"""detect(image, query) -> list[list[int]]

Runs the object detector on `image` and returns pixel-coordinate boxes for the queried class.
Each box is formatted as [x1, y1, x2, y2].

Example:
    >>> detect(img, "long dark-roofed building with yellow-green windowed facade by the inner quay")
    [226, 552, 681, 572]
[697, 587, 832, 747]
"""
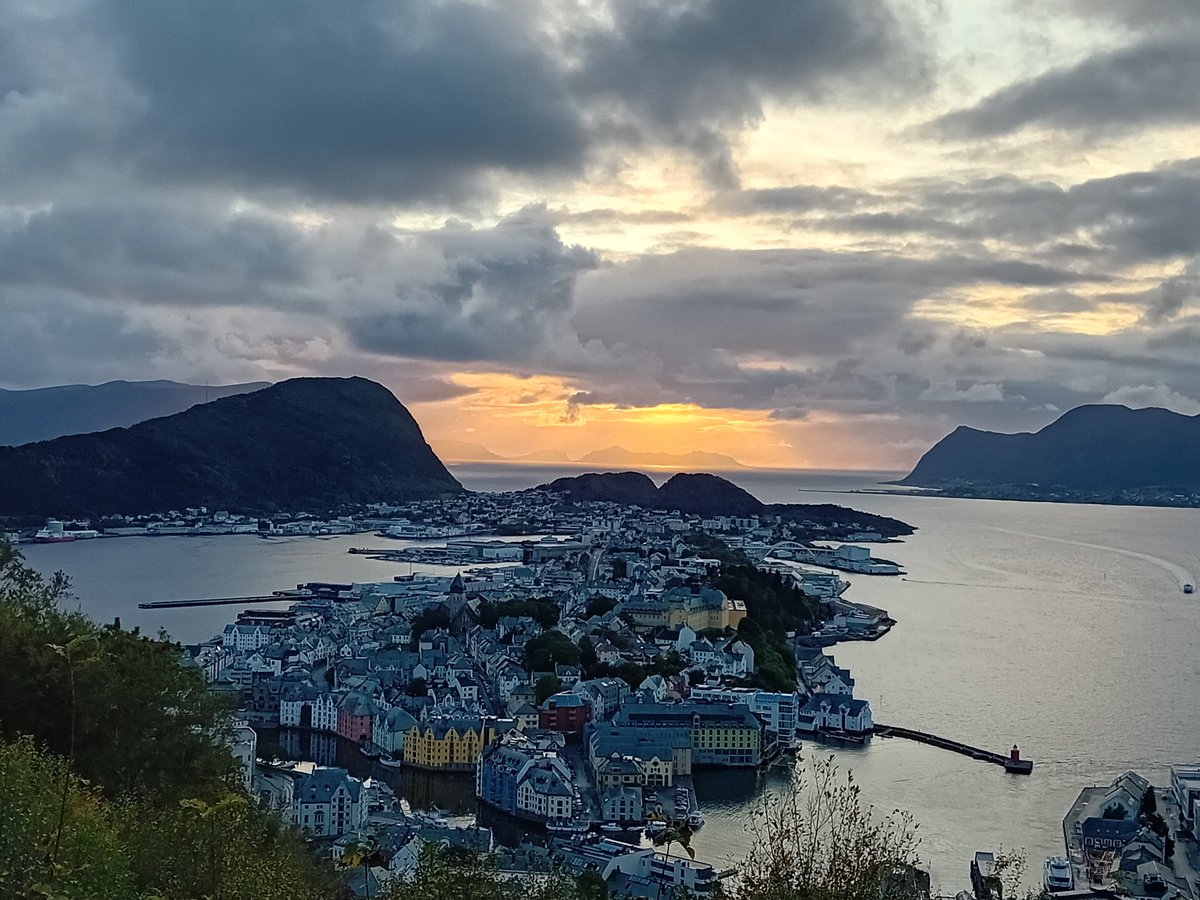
[614, 701, 762, 767]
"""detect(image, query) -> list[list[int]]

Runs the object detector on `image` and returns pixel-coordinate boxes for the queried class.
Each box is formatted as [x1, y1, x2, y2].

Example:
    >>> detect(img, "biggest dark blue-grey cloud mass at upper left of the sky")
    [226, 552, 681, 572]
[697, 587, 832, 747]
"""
[100, 0, 586, 200]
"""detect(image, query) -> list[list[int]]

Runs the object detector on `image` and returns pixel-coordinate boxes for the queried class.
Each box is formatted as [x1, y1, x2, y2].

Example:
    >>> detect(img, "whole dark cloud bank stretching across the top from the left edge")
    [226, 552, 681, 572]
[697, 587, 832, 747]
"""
[0, 0, 925, 204]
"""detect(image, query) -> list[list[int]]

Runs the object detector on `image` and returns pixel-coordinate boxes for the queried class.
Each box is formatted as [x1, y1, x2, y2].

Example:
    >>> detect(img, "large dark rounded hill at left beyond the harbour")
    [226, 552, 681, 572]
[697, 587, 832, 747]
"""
[0, 378, 462, 516]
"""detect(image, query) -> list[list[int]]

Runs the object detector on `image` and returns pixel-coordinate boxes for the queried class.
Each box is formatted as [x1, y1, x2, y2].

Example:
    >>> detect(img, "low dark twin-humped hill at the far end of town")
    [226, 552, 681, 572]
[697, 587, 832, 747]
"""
[532, 472, 913, 538]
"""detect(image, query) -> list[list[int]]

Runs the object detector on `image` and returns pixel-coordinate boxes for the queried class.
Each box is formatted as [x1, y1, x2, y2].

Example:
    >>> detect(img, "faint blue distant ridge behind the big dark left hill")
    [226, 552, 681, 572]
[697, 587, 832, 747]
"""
[0, 382, 270, 446]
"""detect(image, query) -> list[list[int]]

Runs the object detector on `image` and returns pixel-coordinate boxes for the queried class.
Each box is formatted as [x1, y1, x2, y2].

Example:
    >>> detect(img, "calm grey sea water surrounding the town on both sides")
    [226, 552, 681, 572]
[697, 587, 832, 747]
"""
[18, 464, 1200, 892]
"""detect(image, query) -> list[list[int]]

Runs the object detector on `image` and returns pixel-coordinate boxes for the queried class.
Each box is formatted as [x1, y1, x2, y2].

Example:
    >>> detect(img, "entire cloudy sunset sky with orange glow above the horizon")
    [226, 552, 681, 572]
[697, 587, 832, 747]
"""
[0, 0, 1200, 469]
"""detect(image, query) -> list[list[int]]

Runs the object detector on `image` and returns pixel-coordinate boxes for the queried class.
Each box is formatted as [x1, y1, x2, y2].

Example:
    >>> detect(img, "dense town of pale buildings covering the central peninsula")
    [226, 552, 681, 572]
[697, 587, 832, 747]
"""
[171, 492, 899, 895]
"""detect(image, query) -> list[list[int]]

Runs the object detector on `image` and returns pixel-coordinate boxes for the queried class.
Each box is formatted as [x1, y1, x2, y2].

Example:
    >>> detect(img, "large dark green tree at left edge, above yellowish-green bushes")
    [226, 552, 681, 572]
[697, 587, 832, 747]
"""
[0, 546, 234, 799]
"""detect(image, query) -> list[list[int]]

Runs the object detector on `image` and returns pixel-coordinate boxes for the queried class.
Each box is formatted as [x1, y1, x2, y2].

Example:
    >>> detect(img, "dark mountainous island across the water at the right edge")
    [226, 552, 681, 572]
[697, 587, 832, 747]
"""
[895, 404, 1200, 506]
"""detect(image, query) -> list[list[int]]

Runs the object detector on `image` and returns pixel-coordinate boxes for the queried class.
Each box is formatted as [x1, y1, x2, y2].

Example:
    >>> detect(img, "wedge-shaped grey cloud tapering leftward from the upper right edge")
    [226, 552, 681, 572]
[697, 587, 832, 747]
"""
[926, 32, 1200, 138]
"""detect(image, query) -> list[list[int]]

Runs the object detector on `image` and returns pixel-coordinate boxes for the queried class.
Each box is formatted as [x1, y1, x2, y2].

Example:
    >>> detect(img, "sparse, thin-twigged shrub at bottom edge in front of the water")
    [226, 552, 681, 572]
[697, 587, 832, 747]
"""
[731, 756, 918, 900]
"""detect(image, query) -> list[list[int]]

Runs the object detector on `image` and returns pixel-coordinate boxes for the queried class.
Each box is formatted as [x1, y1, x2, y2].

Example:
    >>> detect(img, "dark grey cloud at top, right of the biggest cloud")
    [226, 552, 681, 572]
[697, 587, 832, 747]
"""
[574, 0, 929, 187]
